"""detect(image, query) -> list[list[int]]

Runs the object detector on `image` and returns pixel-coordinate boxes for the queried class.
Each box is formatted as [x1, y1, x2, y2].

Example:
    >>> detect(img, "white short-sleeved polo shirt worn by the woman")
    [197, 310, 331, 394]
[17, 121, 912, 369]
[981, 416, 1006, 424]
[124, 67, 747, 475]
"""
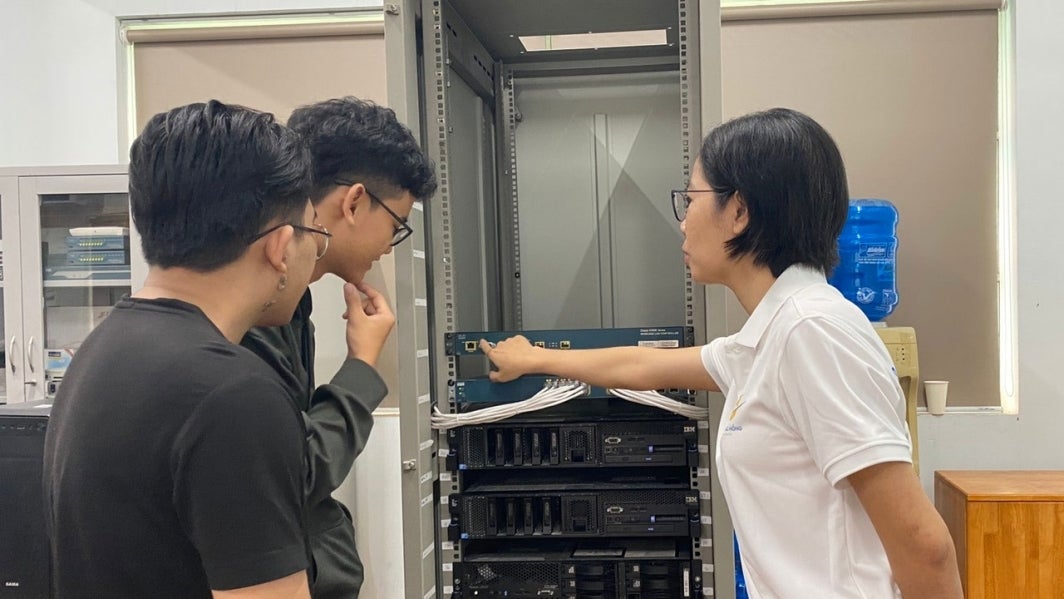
[702, 266, 912, 599]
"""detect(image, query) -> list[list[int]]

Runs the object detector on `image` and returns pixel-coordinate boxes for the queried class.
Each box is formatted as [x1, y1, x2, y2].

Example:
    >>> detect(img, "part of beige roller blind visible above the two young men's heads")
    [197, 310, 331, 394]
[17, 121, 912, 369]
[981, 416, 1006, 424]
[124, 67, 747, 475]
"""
[127, 23, 387, 131]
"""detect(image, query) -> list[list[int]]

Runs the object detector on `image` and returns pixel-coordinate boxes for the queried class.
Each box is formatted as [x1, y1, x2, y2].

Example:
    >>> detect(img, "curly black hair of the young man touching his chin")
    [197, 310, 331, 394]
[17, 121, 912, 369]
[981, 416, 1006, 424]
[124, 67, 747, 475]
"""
[288, 96, 436, 203]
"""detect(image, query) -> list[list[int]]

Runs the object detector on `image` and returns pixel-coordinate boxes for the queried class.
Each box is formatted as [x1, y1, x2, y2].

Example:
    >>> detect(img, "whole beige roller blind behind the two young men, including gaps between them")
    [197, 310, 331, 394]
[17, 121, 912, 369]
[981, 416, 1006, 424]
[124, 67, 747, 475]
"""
[124, 21, 401, 407]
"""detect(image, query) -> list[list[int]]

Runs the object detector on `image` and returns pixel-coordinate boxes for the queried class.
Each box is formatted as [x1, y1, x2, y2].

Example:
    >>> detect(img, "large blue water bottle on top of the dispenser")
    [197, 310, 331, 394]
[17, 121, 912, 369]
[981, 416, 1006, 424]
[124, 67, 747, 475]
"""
[828, 199, 898, 322]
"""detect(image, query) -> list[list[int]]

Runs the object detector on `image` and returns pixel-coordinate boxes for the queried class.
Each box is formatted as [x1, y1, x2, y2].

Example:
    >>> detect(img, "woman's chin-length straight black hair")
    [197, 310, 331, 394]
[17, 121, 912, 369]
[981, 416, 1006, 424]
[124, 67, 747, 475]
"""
[698, 109, 849, 277]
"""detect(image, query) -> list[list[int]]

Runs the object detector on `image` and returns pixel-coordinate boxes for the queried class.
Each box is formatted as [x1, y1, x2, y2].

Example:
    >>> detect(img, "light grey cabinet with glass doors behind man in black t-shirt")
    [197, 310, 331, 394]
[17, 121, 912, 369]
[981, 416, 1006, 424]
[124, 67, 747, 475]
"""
[0, 166, 143, 403]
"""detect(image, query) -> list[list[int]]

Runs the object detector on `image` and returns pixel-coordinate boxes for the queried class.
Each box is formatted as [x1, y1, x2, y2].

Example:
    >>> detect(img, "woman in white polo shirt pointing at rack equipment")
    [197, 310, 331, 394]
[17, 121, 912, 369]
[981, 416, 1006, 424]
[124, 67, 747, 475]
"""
[481, 109, 962, 599]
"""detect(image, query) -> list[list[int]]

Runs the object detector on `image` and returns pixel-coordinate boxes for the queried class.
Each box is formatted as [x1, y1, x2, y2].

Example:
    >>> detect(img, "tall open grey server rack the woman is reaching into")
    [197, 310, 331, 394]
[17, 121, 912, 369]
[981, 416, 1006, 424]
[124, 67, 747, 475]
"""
[384, 0, 730, 599]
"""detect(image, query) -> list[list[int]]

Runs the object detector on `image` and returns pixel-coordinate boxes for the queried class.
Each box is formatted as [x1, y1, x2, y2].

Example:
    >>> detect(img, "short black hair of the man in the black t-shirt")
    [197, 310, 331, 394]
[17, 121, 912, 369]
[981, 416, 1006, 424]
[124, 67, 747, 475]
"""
[130, 100, 311, 272]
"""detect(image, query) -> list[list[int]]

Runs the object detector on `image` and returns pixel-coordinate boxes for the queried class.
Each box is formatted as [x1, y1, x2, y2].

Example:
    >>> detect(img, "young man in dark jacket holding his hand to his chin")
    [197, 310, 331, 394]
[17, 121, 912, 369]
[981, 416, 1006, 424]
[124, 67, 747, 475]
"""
[243, 97, 436, 599]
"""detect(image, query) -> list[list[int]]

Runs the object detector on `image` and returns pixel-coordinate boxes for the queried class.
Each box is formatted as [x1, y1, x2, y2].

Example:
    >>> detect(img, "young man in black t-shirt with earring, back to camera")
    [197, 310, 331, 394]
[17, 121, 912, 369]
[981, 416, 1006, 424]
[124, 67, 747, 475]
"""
[45, 101, 336, 599]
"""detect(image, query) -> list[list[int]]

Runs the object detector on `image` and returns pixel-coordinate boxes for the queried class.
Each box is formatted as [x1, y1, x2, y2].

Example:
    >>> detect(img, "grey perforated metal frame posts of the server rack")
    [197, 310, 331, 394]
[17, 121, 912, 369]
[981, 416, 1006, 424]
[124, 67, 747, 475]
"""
[384, 0, 731, 599]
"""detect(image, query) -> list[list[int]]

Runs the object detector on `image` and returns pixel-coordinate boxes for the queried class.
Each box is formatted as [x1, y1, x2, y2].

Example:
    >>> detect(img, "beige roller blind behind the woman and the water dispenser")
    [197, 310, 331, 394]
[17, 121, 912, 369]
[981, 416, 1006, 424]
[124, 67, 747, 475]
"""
[721, 0, 1000, 405]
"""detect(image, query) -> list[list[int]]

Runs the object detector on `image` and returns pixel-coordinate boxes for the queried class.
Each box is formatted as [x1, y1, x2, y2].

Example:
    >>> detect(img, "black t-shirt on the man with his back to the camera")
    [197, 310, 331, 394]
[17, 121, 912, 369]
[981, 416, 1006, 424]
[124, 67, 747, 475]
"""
[45, 299, 307, 599]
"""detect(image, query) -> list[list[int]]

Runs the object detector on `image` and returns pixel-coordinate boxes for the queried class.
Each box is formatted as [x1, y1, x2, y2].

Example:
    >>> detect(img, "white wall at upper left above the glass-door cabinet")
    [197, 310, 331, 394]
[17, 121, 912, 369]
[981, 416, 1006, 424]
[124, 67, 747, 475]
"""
[0, 0, 381, 167]
